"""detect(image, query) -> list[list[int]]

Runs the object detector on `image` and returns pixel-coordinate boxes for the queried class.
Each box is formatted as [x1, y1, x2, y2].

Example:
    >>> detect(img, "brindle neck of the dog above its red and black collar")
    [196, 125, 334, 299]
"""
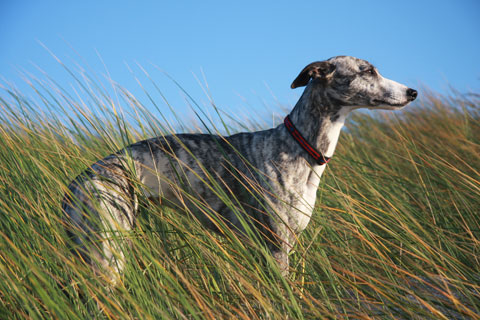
[284, 83, 350, 161]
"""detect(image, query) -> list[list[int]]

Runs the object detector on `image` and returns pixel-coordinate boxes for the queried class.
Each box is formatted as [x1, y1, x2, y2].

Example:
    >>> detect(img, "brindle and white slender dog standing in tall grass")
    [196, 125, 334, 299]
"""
[62, 56, 417, 282]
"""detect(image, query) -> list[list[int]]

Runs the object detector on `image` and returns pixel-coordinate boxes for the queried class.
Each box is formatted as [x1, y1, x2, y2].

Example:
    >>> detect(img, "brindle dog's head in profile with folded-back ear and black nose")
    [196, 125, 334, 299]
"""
[291, 56, 417, 109]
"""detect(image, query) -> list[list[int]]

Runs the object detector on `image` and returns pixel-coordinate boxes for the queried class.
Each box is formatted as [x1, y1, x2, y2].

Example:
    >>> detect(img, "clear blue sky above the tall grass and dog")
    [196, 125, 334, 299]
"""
[0, 0, 480, 120]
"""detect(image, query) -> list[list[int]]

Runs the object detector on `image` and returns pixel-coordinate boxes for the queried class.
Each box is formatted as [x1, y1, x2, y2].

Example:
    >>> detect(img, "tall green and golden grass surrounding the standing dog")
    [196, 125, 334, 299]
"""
[0, 69, 480, 319]
